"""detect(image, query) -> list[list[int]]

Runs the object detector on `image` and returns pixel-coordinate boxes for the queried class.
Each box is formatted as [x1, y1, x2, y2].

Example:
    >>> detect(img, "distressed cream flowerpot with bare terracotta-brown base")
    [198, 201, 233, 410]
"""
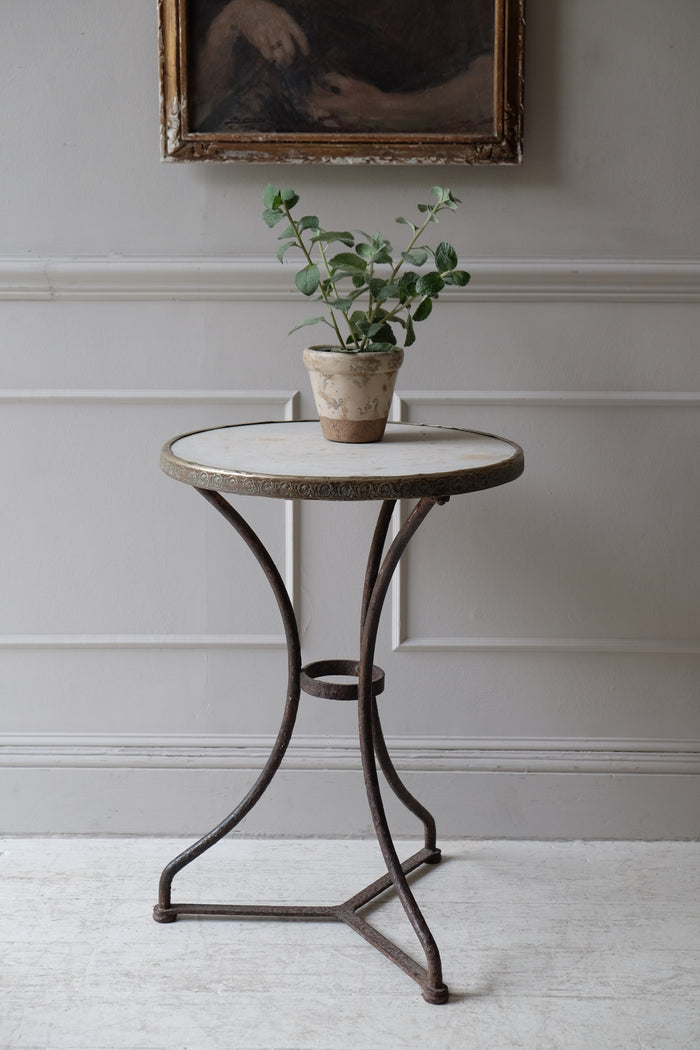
[303, 347, 403, 442]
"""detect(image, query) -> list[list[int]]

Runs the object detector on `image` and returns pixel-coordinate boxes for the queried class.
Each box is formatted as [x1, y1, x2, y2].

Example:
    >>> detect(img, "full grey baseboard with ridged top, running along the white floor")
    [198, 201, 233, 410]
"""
[0, 736, 700, 839]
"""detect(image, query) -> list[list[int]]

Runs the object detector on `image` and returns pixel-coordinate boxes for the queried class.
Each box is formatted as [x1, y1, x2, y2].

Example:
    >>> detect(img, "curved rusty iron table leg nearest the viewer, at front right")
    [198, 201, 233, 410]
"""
[358, 497, 448, 1003]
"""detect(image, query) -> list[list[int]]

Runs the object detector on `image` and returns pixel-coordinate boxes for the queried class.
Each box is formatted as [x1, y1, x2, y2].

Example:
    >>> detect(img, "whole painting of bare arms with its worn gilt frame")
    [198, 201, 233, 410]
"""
[158, 0, 525, 164]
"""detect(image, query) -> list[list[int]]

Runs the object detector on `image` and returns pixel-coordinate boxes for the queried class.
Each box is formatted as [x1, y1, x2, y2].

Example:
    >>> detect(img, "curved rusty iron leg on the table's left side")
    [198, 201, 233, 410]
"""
[153, 488, 301, 922]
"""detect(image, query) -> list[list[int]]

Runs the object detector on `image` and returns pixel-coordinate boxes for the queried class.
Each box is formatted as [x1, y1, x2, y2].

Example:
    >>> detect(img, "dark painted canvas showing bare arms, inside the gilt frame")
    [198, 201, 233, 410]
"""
[188, 0, 495, 134]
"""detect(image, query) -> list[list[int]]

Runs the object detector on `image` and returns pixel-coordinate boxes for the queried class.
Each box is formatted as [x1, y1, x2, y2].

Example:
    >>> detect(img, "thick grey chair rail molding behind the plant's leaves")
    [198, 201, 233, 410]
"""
[0, 255, 700, 302]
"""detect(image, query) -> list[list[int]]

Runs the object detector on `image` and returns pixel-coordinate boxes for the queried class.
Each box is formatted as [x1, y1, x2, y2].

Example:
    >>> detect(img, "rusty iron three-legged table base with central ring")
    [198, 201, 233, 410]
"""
[153, 488, 448, 1004]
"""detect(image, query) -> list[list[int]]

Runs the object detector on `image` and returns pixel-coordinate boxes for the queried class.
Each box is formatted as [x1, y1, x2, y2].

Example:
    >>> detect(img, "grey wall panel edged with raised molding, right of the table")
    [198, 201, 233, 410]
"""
[393, 391, 700, 654]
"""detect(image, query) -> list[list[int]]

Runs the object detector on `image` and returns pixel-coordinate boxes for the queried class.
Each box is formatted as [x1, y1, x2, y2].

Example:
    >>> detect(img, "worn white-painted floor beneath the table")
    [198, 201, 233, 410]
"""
[0, 838, 700, 1050]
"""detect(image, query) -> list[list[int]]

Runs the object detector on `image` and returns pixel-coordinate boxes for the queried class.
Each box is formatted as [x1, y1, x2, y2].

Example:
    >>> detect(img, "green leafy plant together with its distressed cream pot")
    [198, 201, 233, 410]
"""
[262, 185, 469, 442]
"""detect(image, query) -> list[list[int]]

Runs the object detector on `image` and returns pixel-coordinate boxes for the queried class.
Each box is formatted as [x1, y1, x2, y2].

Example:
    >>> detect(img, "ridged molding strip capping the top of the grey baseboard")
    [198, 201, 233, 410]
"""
[0, 733, 700, 776]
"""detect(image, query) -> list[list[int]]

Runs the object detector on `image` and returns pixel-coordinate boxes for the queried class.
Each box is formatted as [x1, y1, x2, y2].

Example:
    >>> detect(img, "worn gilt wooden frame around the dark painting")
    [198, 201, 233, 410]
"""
[158, 0, 525, 164]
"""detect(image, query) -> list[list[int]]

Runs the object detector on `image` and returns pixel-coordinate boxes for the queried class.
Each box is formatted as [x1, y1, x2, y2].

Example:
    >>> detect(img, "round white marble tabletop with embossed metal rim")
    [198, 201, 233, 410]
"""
[161, 422, 523, 500]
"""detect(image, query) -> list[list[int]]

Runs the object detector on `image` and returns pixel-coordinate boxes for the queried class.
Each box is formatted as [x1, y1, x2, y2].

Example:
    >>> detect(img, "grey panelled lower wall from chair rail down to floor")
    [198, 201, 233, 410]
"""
[0, 257, 700, 838]
